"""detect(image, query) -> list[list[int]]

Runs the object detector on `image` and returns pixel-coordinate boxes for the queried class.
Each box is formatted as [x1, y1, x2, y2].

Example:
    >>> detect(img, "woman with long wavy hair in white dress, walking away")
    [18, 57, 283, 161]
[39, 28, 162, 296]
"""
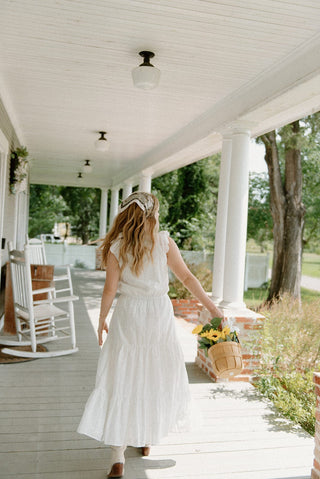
[78, 192, 223, 478]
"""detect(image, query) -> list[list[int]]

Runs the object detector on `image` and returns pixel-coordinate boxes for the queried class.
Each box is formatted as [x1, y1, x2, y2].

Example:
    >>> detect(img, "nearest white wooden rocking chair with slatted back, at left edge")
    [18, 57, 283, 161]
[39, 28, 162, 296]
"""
[0, 243, 79, 358]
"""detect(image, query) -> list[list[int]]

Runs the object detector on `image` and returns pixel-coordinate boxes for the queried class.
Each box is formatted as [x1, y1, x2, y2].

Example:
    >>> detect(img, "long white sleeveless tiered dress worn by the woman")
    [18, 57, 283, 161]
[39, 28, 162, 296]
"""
[77, 231, 190, 447]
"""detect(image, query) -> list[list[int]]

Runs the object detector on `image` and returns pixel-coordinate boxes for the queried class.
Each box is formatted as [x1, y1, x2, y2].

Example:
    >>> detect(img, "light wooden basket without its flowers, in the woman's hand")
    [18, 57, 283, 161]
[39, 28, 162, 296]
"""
[208, 341, 243, 378]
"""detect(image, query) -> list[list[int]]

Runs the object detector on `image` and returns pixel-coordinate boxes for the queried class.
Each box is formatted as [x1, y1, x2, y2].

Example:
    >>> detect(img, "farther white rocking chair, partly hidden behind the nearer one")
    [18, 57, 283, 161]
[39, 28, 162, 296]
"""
[26, 235, 73, 296]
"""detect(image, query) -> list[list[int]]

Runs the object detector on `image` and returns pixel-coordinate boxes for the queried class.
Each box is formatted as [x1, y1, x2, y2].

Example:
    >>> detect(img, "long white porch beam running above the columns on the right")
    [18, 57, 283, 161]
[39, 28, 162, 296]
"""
[114, 33, 320, 188]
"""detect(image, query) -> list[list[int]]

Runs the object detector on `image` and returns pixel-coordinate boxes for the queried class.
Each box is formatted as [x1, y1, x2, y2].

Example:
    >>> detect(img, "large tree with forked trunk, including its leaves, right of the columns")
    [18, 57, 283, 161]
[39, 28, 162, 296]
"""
[258, 113, 320, 301]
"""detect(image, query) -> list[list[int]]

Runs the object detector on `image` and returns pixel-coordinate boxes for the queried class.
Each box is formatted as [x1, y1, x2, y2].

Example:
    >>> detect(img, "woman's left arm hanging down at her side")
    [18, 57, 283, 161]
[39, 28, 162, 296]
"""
[98, 252, 120, 346]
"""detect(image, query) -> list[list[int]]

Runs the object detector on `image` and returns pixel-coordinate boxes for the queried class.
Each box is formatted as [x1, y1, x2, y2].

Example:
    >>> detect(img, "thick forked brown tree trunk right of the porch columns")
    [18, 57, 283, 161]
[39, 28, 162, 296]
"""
[261, 121, 305, 302]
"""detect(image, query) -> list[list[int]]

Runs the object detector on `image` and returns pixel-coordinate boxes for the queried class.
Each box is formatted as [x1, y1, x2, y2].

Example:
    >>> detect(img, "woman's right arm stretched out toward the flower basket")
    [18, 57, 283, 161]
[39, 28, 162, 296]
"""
[168, 238, 223, 318]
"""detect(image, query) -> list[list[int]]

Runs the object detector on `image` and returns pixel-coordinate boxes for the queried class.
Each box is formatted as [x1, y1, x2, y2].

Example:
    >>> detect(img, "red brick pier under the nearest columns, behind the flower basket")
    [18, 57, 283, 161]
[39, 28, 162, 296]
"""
[196, 308, 264, 384]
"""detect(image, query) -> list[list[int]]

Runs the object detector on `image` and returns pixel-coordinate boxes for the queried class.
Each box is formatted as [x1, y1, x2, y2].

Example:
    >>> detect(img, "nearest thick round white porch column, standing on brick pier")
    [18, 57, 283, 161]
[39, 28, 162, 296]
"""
[220, 127, 250, 309]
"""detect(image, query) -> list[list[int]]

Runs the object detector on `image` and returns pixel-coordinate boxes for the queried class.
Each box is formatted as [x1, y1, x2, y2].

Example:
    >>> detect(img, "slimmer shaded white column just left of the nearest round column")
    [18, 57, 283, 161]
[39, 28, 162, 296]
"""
[212, 134, 232, 303]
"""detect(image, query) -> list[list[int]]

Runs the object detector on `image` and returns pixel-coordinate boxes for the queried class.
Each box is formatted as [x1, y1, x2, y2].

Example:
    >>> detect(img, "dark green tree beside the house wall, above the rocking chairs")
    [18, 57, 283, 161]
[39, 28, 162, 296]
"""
[29, 185, 67, 238]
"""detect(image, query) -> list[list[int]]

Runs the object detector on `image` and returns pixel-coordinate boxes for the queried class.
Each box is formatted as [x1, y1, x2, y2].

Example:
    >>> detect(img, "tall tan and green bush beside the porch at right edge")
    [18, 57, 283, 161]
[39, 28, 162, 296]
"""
[255, 296, 320, 434]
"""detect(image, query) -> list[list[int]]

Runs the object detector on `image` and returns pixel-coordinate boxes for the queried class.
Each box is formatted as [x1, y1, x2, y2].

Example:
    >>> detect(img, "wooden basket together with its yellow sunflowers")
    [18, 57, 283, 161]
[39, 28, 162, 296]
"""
[192, 318, 243, 378]
